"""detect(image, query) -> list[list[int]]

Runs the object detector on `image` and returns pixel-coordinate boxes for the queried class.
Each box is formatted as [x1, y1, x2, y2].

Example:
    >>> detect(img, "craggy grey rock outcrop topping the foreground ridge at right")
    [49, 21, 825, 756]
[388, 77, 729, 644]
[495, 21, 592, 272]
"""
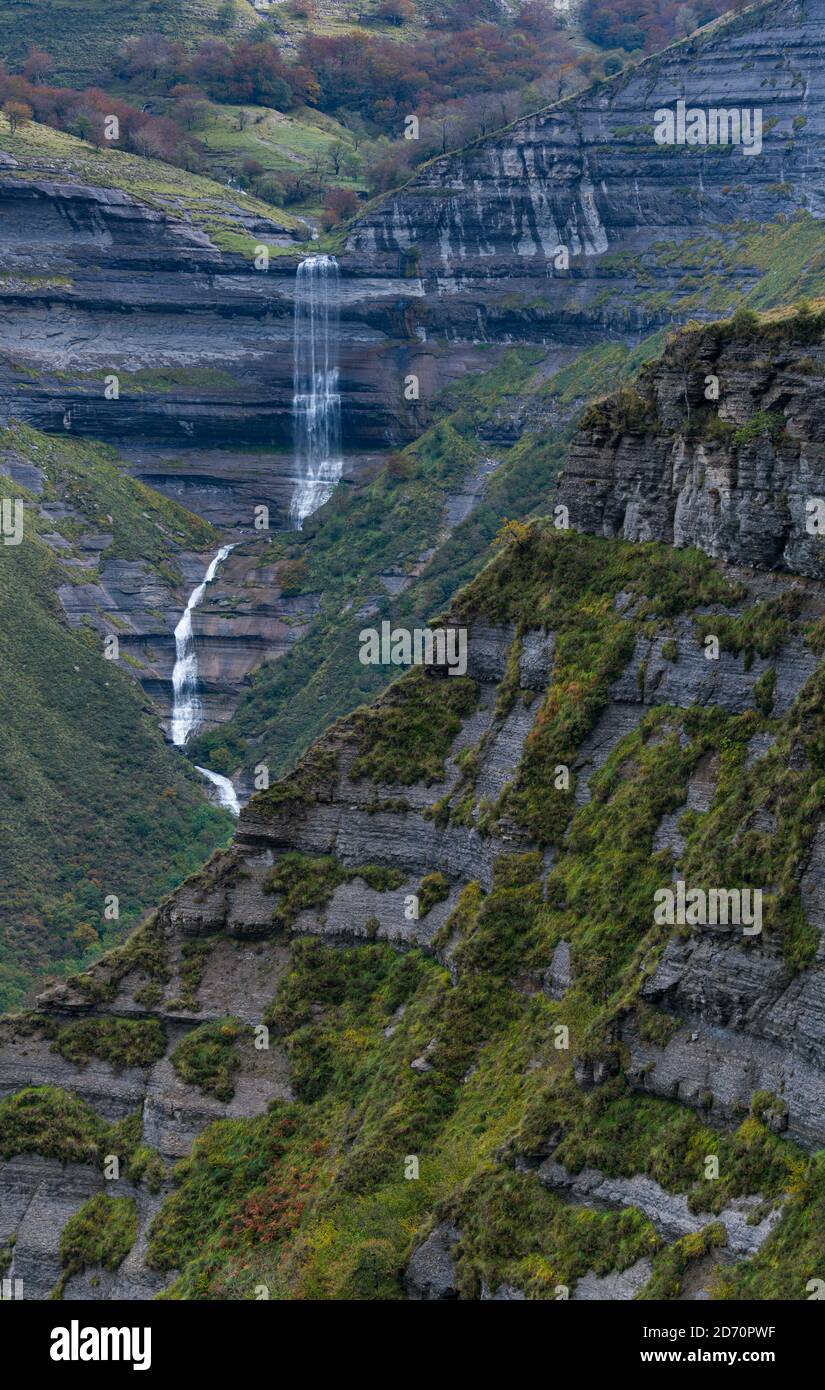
[558, 316, 825, 580]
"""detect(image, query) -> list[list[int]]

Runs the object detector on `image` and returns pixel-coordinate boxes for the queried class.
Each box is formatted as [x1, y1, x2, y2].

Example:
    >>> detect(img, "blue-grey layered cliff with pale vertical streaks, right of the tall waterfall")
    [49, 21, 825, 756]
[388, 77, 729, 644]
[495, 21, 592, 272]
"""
[349, 0, 825, 329]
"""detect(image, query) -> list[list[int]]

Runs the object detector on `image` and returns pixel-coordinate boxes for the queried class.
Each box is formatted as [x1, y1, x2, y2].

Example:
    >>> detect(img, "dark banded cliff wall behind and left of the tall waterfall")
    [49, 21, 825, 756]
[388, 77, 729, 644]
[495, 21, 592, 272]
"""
[0, 170, 408, 503]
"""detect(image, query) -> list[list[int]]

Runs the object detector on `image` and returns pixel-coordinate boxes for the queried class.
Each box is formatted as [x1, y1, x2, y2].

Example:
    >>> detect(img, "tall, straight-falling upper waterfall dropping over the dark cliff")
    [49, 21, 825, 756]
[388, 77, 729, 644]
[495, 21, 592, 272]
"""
[289, 256, 342, 531]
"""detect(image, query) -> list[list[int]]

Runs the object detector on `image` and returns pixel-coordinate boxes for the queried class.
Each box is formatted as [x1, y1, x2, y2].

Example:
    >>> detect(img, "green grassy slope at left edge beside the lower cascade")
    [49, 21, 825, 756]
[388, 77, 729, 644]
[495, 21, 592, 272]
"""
[0, 430, 231, 1009]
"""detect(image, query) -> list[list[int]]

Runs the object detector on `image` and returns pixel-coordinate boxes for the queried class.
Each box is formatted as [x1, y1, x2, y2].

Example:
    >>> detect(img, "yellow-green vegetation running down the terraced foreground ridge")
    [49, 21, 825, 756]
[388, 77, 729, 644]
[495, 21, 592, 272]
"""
[165, 523, 825, 1298]
